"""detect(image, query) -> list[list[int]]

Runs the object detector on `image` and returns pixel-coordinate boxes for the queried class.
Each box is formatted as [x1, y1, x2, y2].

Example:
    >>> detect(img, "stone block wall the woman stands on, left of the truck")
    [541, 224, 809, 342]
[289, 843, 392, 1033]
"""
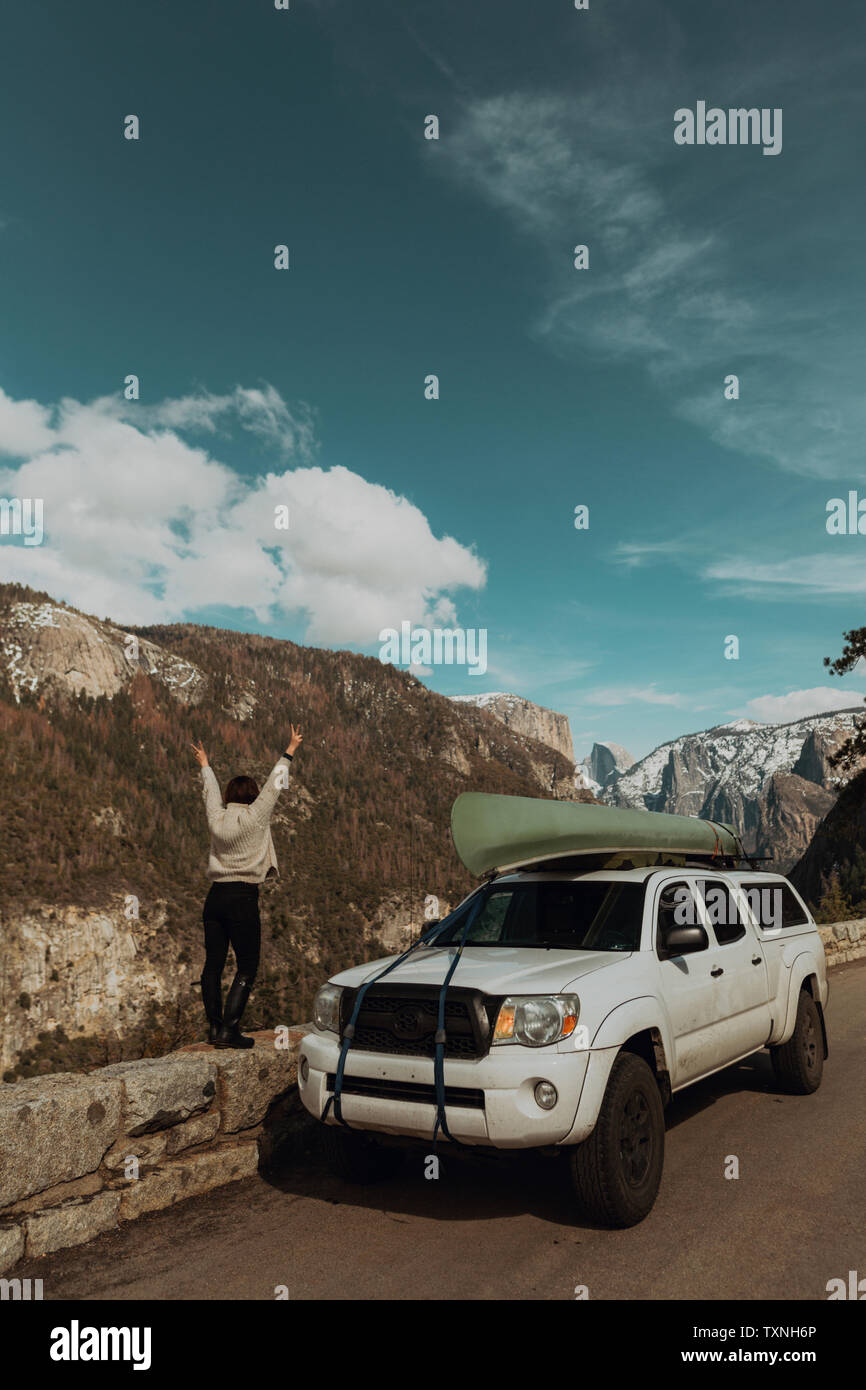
[0, 1024, 310, 1273]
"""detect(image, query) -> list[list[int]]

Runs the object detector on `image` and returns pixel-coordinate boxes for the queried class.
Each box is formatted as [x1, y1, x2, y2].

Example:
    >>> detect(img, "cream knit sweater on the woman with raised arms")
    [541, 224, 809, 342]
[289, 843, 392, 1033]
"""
[202, 756, 292, 883]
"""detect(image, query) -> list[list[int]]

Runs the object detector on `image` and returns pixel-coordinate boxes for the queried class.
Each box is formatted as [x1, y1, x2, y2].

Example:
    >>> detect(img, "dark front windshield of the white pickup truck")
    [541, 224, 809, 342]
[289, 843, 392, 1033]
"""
[428, 880, 644, 951]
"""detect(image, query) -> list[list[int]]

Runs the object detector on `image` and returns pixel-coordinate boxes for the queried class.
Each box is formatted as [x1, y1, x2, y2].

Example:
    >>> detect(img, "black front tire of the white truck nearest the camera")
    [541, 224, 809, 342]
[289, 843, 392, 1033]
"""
[569, 1052, 664, 1226]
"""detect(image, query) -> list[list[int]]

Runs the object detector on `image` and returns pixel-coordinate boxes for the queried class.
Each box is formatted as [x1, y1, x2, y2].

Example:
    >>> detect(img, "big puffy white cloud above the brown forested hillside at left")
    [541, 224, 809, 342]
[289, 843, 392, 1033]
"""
[0, 388, 487, 648]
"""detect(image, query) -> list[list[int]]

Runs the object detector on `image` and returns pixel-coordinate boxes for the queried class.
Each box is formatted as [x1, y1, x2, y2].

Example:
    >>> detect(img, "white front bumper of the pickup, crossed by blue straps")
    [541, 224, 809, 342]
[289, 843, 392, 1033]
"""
[297, 1031, 589, 1148]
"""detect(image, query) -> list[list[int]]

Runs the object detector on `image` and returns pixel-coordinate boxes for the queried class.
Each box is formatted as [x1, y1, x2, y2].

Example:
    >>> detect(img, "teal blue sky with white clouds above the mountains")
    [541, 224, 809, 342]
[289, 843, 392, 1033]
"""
[0, 0, 866, 756]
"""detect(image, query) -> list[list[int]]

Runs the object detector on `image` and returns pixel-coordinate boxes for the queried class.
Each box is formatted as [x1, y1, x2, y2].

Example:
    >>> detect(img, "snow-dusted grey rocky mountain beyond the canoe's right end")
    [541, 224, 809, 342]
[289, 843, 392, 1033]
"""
[601, 710, 862, 873]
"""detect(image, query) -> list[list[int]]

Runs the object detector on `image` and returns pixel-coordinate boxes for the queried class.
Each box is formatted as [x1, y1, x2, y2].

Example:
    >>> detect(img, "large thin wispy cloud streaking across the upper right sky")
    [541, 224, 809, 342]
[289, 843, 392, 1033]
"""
[435, 63, 866, 477]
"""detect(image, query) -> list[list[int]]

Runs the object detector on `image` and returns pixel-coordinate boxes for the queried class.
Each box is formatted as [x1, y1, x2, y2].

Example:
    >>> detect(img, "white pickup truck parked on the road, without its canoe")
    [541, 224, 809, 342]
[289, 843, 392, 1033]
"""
[299, 865, 828, 1226]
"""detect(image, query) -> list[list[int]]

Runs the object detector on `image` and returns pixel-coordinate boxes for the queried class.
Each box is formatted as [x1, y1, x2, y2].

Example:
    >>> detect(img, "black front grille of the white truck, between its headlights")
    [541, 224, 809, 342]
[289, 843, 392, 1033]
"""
[341, 983, 502, 1059]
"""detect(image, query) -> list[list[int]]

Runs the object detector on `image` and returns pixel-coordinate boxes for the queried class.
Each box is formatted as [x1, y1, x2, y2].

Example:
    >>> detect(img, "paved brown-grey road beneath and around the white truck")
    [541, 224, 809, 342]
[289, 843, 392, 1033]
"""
[15, 962, 866, 1300]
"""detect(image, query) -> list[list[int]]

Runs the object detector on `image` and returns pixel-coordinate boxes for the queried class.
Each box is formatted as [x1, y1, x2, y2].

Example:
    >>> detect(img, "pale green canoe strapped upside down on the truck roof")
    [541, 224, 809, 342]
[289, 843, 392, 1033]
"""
[450, 791, 742, 874]
